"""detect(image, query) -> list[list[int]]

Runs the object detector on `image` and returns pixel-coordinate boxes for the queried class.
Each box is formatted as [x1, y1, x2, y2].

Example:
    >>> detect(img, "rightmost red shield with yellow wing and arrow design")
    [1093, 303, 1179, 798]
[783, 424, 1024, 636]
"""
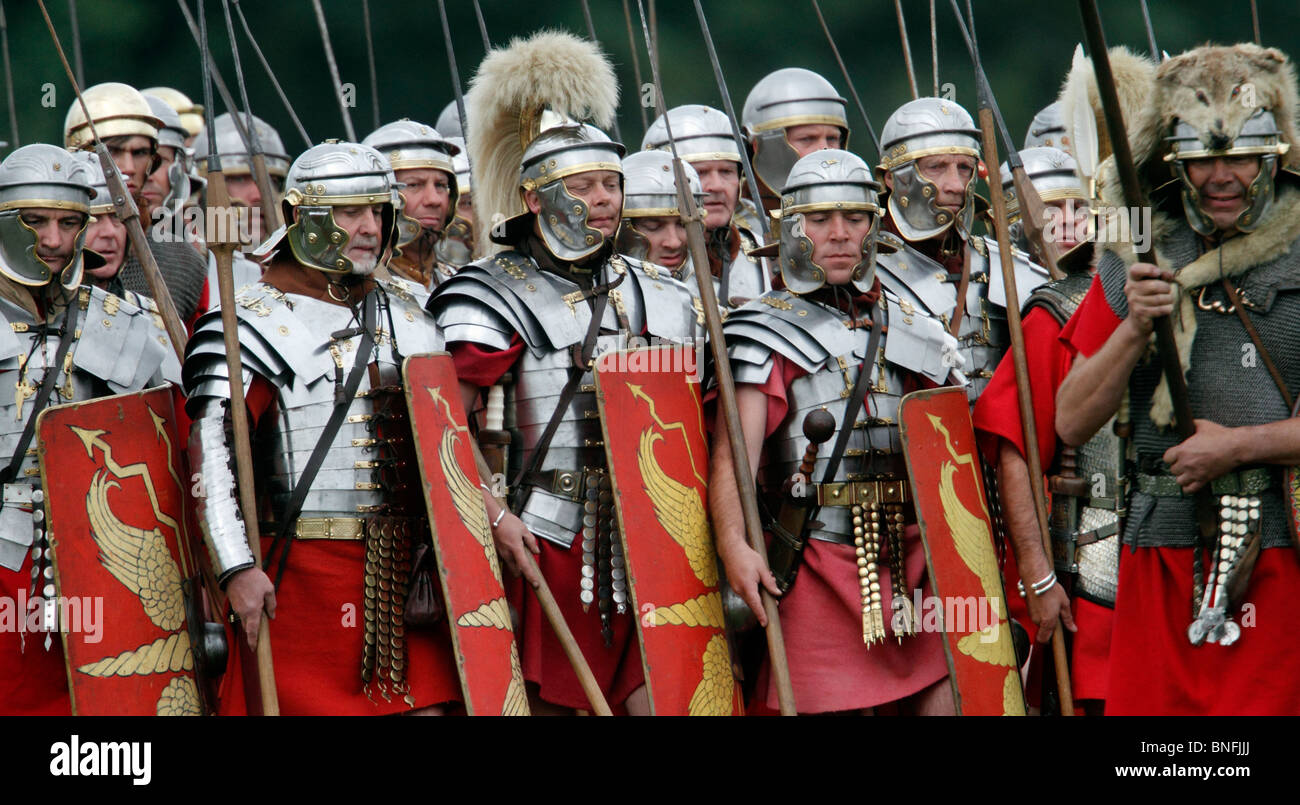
[898, 388, 1024, 715]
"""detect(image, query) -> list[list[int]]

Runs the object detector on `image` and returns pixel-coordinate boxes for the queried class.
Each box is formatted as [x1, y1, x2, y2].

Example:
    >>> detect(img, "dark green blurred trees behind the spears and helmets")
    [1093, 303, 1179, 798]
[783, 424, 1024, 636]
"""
[0, 0, 1300, 161]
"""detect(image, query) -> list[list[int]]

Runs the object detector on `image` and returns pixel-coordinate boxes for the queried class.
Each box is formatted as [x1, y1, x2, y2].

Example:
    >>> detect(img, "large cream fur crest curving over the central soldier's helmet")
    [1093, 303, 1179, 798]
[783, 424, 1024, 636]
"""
[465, 31, 619, 256]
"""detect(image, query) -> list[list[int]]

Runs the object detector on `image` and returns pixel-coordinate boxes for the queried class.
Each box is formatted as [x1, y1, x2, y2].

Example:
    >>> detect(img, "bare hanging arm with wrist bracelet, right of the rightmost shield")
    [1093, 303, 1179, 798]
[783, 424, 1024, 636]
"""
[997, 440, 1078, 642]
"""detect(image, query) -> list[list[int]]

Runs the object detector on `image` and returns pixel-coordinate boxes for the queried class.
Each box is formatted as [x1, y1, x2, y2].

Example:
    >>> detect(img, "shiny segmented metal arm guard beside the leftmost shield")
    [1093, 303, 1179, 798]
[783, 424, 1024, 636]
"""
[189, 398, 255, 585]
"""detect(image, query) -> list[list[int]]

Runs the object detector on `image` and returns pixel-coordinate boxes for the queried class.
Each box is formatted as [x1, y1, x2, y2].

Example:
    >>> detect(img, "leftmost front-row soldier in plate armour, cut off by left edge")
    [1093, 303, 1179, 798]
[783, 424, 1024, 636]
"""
[0, 144, 179, 715]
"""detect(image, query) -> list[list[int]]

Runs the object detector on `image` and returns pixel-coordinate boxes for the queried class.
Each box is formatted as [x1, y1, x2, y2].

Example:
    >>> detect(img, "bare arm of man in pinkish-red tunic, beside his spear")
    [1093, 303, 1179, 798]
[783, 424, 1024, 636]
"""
[709, 385, 780, 627]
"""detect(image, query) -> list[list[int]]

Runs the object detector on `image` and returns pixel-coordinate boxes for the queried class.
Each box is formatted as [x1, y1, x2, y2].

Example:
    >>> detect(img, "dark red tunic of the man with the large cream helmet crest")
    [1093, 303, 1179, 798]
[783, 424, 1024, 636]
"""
[447, 333, 645, 710]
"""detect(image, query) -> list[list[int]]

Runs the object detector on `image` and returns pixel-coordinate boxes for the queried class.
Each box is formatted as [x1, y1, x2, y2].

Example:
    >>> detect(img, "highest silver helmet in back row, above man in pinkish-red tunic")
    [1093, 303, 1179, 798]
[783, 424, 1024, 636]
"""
[743, 68, 849, 190]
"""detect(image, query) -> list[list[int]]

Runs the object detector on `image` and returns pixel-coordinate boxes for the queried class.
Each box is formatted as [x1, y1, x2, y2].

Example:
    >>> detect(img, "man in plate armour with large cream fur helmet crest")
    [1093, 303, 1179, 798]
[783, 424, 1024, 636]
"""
[429, 33, 698, 714]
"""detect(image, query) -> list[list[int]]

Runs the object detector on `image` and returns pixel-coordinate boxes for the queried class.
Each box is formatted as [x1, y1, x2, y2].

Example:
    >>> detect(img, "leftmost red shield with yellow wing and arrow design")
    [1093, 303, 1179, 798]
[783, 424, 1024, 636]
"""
[36, 386, 202, 715]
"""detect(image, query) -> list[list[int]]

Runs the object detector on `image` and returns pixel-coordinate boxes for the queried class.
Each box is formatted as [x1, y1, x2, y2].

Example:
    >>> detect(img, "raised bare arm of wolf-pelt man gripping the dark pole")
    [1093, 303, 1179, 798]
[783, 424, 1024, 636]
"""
[1056, 263, 1174, 447]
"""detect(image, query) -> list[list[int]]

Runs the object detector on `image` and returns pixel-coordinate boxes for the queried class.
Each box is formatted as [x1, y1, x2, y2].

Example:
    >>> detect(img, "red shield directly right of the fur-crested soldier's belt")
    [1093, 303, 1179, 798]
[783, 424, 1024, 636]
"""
[595, 346, 744, 715]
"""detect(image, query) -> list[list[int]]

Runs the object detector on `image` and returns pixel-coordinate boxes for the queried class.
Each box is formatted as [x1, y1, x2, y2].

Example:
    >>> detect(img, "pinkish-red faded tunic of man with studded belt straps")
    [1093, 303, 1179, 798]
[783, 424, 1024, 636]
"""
[758, 354, 948, 713]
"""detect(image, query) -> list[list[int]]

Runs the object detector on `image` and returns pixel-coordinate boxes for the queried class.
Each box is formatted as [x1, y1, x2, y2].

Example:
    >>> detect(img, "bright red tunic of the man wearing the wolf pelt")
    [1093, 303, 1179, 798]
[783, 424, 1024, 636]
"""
[1061, 280, 1300, 715]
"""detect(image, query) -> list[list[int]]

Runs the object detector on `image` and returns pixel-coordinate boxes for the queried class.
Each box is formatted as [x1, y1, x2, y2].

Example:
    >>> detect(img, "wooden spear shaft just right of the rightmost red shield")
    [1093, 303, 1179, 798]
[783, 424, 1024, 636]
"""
[967, 105, 1074, 715]
